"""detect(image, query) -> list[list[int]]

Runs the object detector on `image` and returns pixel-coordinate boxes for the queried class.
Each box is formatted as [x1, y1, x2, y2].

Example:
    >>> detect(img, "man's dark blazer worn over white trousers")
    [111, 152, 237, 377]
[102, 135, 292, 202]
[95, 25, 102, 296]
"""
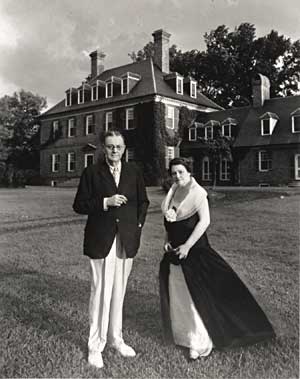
[73, 162, 149, 259]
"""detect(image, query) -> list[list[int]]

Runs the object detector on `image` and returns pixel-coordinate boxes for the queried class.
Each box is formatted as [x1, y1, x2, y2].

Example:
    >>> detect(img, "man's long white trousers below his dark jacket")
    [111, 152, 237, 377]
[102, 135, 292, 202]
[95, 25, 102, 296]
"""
[88, 234, 133, 351]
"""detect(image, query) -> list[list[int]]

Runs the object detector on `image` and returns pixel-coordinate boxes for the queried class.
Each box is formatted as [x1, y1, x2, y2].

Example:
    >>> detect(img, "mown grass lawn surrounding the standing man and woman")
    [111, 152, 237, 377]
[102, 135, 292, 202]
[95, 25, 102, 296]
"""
[0, 187, 300, 379]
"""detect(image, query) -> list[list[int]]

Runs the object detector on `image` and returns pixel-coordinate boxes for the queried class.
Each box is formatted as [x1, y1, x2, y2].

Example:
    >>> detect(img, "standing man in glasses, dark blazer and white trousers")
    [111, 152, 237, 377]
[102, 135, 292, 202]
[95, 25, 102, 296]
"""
[73, 131, 149, 368]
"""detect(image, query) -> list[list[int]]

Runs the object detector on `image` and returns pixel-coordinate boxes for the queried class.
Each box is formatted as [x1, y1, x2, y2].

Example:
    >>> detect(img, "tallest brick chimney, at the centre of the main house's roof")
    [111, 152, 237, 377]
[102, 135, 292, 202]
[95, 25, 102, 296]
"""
[152, 29, 171, 74]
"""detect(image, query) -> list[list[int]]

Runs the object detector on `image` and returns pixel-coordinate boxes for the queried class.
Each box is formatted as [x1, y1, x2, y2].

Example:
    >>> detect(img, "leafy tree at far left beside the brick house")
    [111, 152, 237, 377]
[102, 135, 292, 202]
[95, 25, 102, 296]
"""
[0, 90, 46, 183]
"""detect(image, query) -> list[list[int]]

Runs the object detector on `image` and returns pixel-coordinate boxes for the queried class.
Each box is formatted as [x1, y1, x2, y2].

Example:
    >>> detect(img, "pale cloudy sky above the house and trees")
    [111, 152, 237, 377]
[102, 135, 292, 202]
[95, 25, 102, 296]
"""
[0, 0, 300, 110]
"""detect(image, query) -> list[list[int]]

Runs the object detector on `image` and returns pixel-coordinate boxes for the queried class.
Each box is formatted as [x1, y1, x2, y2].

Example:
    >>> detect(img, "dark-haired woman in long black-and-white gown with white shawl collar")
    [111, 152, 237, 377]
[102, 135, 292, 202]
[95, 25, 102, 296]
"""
[160, 158, 275, 359]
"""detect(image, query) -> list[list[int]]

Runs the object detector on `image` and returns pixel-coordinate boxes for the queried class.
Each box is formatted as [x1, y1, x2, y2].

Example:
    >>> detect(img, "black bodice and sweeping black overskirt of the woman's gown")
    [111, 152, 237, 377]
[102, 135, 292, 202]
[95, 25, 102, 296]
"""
[159, 214, 275, 348]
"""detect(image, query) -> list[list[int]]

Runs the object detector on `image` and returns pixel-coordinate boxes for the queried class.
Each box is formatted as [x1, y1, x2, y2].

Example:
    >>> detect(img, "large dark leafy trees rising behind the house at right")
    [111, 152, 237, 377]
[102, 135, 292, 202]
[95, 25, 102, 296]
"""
[132, 23, 300, 108]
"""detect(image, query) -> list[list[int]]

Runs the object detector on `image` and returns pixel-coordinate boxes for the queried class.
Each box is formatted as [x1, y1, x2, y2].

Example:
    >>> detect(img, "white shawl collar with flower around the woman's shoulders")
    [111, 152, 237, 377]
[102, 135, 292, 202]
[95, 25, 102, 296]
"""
[161, 177, 207, 222]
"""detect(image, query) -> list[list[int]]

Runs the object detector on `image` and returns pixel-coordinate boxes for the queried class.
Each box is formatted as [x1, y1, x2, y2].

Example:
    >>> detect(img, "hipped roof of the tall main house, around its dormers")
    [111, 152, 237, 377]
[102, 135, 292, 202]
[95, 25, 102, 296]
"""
[41, 58, 223, 117]
